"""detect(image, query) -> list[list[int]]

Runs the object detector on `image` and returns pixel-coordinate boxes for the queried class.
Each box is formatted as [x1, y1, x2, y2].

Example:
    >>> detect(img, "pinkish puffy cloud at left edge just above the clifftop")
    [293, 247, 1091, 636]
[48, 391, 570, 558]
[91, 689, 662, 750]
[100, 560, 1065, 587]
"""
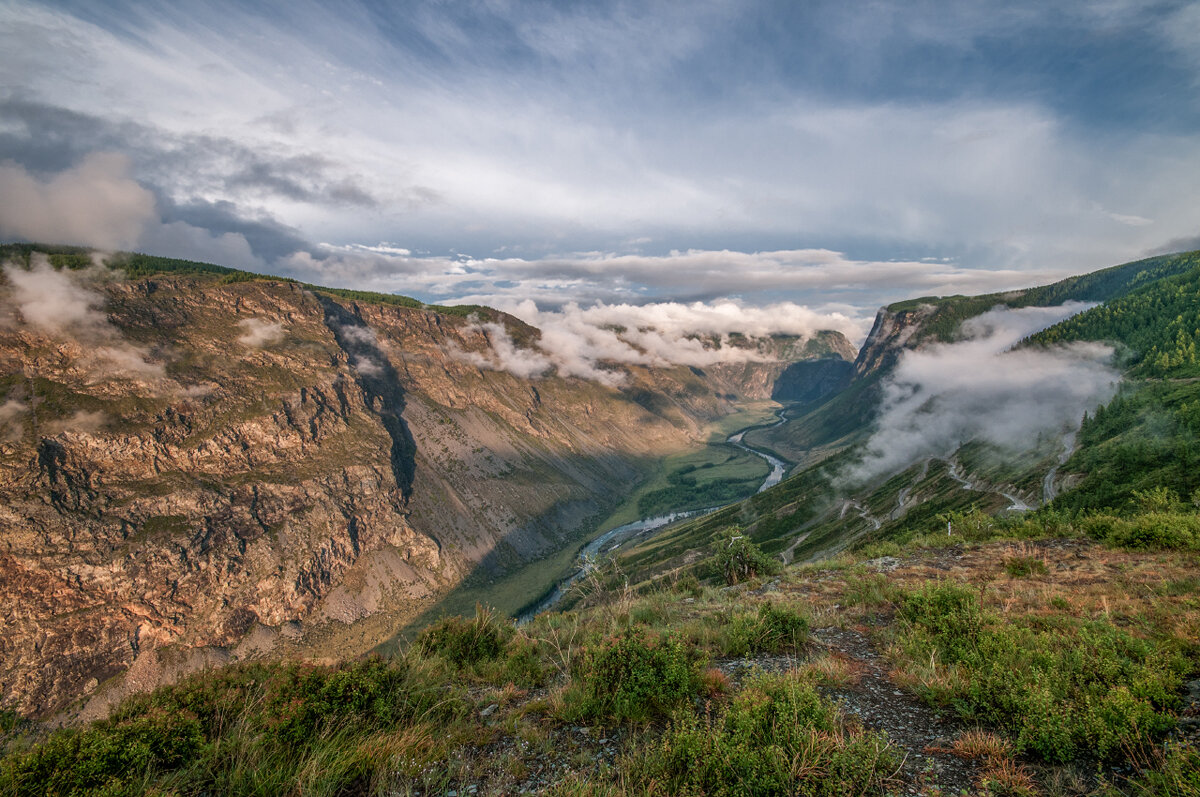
[0, 152, 155, 250]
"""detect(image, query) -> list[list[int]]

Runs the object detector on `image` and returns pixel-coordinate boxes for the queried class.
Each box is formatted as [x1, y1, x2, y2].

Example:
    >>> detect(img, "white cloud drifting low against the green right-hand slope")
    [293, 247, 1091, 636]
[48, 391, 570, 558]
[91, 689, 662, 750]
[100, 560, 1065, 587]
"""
[845, 302, 1121, 483]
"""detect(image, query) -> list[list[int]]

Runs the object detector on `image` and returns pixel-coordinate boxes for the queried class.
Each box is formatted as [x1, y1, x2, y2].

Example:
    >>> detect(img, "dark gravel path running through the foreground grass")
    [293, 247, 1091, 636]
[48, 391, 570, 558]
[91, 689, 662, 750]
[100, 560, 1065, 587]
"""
[812, 628, 976, 795]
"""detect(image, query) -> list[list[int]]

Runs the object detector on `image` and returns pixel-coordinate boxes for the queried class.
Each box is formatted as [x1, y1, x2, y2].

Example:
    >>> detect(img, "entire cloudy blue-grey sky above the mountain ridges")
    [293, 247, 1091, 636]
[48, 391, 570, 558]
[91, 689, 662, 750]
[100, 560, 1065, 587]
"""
[0, 0, 1200, 338]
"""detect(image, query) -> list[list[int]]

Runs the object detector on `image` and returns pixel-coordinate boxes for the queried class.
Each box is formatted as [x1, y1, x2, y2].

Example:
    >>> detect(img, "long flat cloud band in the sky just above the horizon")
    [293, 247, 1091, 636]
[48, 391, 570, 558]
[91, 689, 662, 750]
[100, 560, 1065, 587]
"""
[278, 246, 1066, 316]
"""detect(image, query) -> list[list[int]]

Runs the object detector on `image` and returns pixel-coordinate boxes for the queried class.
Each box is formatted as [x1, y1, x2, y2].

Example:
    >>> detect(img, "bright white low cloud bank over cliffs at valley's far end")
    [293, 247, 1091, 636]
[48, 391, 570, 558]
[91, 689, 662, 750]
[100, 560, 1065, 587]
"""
[455, 300, 863, 386]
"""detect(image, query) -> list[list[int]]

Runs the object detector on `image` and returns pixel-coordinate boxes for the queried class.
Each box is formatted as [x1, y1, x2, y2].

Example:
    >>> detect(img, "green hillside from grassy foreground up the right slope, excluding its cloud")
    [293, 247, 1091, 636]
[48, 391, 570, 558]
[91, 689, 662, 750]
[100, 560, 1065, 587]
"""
[0, 247, 1200, 797]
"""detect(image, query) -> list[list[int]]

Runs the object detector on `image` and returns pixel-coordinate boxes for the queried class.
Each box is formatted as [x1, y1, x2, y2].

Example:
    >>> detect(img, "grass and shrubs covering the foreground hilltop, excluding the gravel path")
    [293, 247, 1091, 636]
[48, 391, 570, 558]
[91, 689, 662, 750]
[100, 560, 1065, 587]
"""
[0, 521, 1200, 796]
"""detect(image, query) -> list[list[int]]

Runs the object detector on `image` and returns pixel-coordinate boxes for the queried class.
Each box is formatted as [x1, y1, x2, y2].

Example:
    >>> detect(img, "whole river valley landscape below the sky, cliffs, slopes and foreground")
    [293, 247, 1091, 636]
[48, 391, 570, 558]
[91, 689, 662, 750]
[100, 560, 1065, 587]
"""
[0, 247, 1200, 797]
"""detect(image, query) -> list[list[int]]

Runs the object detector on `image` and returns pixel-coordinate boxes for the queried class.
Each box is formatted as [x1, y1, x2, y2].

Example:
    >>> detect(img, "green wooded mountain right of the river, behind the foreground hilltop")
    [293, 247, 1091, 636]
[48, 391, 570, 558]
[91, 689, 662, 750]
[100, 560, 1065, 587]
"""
[604, 252, 1200, 582]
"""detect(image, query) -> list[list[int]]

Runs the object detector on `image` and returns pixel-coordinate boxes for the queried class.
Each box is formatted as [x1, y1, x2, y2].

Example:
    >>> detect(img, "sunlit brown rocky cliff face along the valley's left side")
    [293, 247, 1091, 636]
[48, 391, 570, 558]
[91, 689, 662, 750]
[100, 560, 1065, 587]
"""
[0, 266, 854, 714]
